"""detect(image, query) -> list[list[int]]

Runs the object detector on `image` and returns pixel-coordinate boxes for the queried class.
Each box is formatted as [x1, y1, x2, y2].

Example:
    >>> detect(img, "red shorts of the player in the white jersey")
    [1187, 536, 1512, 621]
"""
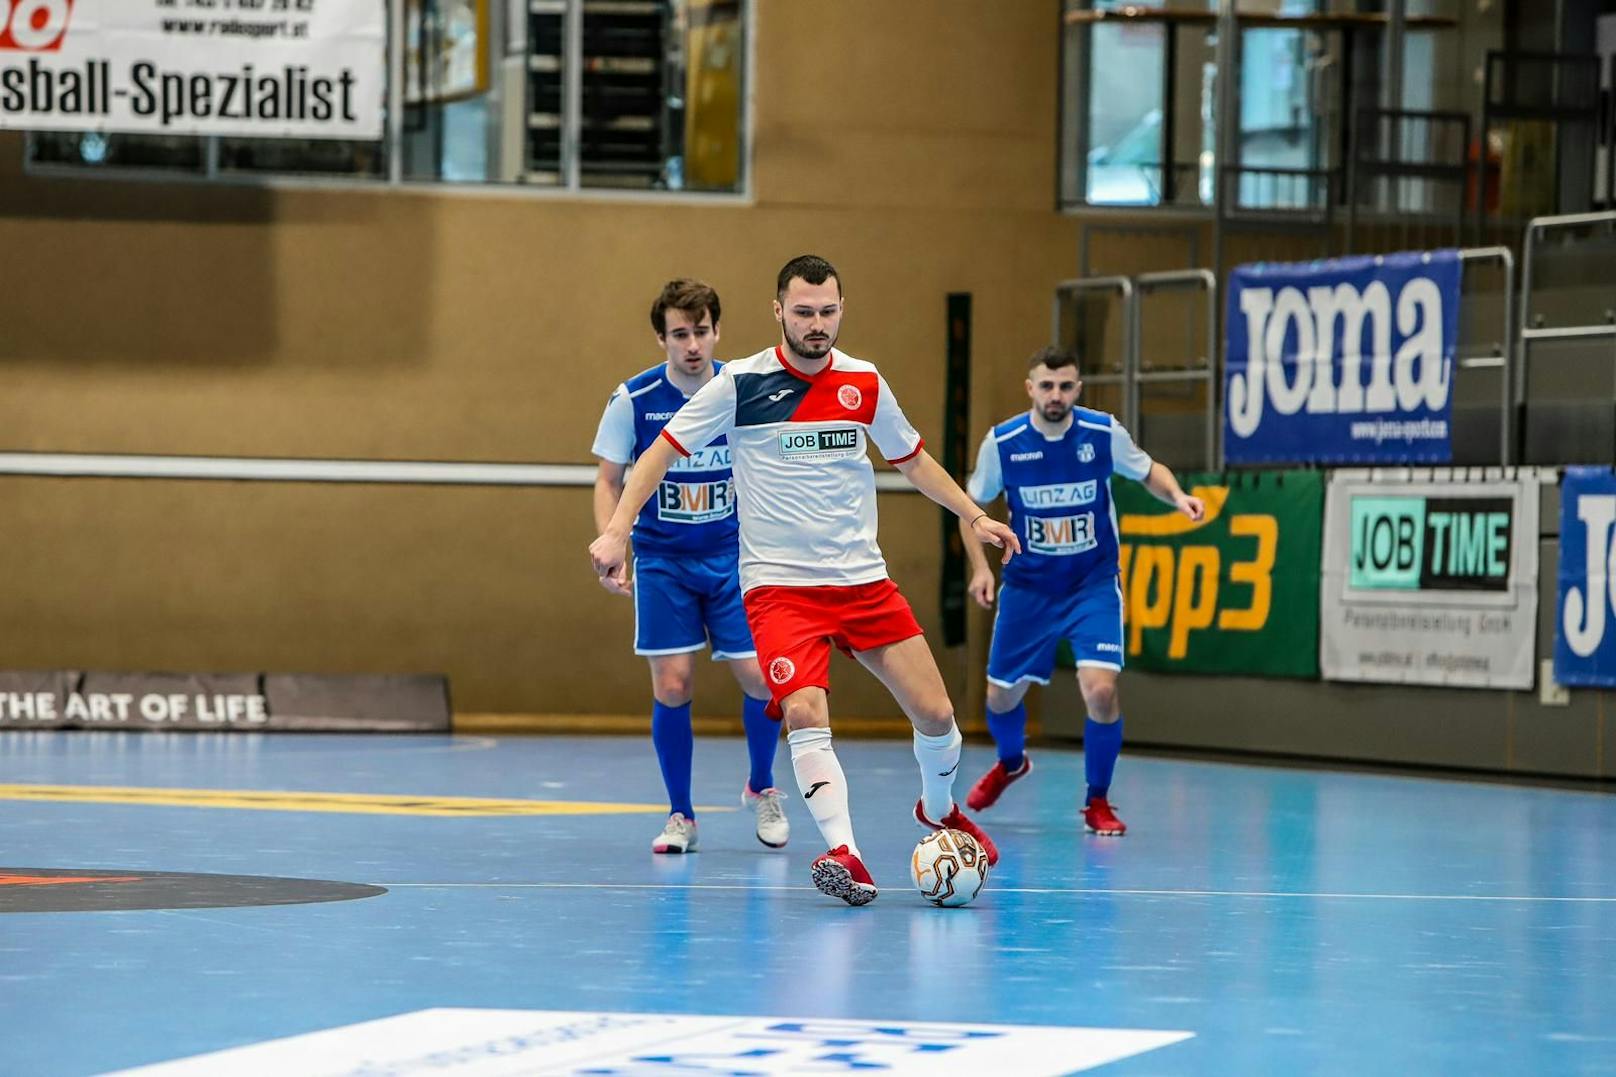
[745, 579, 921, 721]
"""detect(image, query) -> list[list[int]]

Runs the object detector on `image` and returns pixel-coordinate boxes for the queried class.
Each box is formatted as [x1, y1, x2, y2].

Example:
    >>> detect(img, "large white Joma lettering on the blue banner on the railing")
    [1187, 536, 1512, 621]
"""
[1228, 277, 1453, 438]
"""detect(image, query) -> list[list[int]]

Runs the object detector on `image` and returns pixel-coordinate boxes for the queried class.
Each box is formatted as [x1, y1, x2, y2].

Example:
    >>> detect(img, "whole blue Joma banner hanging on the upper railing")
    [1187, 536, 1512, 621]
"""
[1223, 251, 1459, 464]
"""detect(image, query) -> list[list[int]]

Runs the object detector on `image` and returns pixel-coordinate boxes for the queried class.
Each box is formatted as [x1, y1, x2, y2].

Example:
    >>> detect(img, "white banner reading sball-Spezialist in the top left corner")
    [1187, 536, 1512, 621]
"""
[0, 0, 386, 141]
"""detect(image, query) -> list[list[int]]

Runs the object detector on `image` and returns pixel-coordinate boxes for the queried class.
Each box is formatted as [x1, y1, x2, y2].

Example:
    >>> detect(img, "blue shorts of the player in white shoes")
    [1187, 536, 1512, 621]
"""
[633, 553, 758, 661]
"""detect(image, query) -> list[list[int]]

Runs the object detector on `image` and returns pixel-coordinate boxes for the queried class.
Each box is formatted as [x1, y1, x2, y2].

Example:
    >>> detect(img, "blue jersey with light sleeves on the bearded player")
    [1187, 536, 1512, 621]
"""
[968, 408, 1151, 590]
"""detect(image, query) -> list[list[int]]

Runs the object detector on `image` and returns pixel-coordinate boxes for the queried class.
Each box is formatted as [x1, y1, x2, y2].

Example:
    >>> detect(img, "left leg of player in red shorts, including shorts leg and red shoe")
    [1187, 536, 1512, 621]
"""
[747, 587, 876, 906]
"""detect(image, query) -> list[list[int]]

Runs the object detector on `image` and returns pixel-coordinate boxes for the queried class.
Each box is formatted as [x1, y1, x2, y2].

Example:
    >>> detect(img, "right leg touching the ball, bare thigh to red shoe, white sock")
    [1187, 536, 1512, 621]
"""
[853, 636, 999, 864]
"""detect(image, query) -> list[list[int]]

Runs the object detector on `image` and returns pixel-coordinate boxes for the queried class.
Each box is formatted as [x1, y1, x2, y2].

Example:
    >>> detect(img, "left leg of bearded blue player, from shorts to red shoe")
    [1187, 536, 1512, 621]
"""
[965, 584, 1062, 812]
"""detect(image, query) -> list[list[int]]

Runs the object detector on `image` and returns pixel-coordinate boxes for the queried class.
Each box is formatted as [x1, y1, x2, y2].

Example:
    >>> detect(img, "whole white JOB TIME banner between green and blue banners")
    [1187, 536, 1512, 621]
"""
[1319, 469, 1542, 689]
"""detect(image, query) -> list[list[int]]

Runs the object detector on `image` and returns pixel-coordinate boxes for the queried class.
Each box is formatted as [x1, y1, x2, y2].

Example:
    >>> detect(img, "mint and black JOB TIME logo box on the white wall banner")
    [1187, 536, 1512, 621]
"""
[1349, 496, 1514, 590]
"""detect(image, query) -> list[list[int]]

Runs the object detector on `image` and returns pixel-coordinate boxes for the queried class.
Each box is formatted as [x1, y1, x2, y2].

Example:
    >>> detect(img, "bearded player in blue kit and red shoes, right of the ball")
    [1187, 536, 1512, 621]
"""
[965, 348, 1204, 836]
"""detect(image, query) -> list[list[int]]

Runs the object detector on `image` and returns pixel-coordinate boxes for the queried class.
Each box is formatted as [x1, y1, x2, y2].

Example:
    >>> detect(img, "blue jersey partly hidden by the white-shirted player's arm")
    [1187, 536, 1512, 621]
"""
[593, 362, 737, 556]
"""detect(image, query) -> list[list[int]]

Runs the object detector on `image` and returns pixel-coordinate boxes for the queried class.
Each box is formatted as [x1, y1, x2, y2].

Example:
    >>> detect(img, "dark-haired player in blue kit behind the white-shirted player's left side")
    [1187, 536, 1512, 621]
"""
[593, 280, 790, 852]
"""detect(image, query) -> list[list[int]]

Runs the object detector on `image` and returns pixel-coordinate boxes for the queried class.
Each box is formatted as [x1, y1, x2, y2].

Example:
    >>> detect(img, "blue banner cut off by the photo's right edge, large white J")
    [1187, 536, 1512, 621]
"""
[1555, 467, 1616, 687]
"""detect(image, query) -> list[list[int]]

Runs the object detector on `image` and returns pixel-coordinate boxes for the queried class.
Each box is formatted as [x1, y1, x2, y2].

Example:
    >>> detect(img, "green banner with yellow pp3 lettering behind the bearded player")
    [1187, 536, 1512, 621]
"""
[1112, 471, 1324, 678]
